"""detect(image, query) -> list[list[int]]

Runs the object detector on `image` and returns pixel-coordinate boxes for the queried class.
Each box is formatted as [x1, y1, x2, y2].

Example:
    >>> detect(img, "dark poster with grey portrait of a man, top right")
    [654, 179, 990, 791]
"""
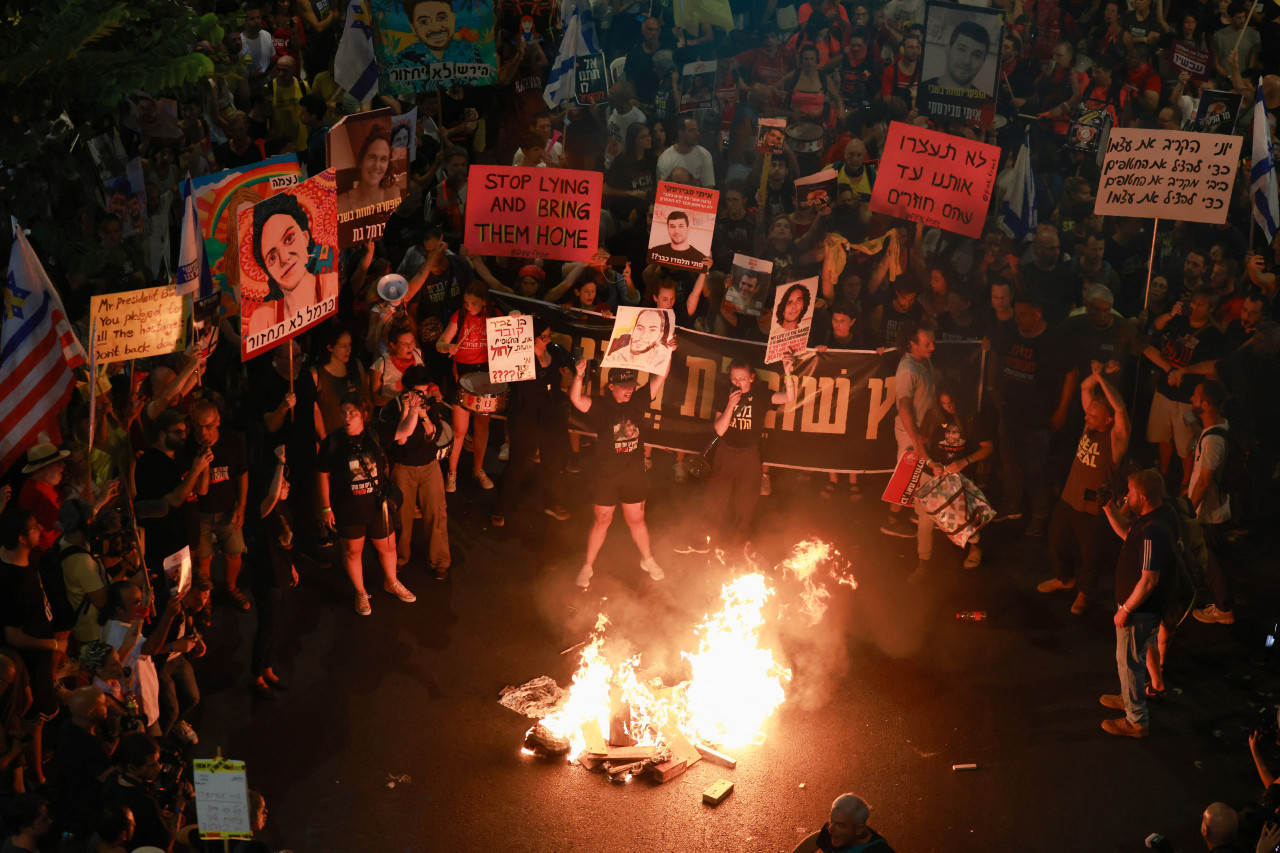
[916, 3, 1005, 131]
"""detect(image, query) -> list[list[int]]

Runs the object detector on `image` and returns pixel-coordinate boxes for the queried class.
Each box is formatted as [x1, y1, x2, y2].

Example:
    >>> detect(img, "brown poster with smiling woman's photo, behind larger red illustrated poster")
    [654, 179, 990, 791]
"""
[326, 109, 408, 250]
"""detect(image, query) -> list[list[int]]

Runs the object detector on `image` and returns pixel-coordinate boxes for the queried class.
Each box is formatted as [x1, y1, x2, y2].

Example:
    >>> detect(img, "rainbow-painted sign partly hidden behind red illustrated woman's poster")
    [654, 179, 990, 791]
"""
[191, 154, 302, 316]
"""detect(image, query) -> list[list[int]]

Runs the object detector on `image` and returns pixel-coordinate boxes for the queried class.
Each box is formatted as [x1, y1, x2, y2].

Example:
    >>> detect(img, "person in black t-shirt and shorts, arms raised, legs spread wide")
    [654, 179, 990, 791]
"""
[568, 360, 666, 589]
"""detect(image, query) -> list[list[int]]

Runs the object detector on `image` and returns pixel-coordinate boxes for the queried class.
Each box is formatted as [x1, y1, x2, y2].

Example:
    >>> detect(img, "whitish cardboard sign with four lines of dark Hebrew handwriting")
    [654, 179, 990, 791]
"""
[1093, 127, 1240, 223]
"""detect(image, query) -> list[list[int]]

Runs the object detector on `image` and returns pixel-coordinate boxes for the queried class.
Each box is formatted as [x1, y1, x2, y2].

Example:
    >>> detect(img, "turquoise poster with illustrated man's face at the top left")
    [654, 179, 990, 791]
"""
[370, 0, 498, 94]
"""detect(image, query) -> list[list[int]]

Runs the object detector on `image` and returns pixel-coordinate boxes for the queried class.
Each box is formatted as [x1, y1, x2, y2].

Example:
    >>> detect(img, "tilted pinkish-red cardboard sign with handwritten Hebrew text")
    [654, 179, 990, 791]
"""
[872, 122, 1000, 237]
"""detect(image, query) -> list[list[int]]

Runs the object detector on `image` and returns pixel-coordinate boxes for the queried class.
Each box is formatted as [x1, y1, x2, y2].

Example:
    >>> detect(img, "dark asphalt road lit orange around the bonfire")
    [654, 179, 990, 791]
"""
[196, 455, 1280, 853]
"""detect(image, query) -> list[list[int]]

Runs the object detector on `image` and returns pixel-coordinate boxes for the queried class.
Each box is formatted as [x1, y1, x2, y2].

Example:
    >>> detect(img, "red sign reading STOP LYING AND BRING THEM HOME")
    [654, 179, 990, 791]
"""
[463, 165, 604, 261]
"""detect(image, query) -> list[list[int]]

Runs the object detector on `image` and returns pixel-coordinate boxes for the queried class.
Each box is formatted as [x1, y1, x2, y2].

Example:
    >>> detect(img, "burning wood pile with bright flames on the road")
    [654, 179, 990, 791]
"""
[503, 542, 856, 783]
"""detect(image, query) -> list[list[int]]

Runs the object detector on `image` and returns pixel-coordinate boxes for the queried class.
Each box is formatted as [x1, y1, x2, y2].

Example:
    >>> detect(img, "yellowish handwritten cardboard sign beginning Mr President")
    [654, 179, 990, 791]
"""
[90, 287, 187, 364]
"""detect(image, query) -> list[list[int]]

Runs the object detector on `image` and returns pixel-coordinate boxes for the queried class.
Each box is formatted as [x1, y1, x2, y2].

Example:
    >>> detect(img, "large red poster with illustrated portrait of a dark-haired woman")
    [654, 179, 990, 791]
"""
[237, 169, 338, 361]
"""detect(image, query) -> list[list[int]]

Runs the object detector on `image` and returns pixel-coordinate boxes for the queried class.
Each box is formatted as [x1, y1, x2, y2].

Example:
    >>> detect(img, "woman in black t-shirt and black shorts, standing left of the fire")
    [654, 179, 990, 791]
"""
[316, 393, 417, 616]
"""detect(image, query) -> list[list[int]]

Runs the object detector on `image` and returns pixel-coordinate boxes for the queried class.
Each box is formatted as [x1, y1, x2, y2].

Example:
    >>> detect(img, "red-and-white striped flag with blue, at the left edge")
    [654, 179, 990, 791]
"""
[0, 219, 87, 471]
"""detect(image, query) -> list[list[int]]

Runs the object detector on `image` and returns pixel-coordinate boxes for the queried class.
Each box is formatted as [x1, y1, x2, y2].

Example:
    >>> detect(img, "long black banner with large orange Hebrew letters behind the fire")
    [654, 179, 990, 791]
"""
[494, 293, 982, 473]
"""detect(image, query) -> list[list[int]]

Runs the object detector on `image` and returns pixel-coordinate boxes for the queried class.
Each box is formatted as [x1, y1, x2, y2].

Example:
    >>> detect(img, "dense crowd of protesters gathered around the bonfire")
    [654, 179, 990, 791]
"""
[0, 0, 1280, 853]
